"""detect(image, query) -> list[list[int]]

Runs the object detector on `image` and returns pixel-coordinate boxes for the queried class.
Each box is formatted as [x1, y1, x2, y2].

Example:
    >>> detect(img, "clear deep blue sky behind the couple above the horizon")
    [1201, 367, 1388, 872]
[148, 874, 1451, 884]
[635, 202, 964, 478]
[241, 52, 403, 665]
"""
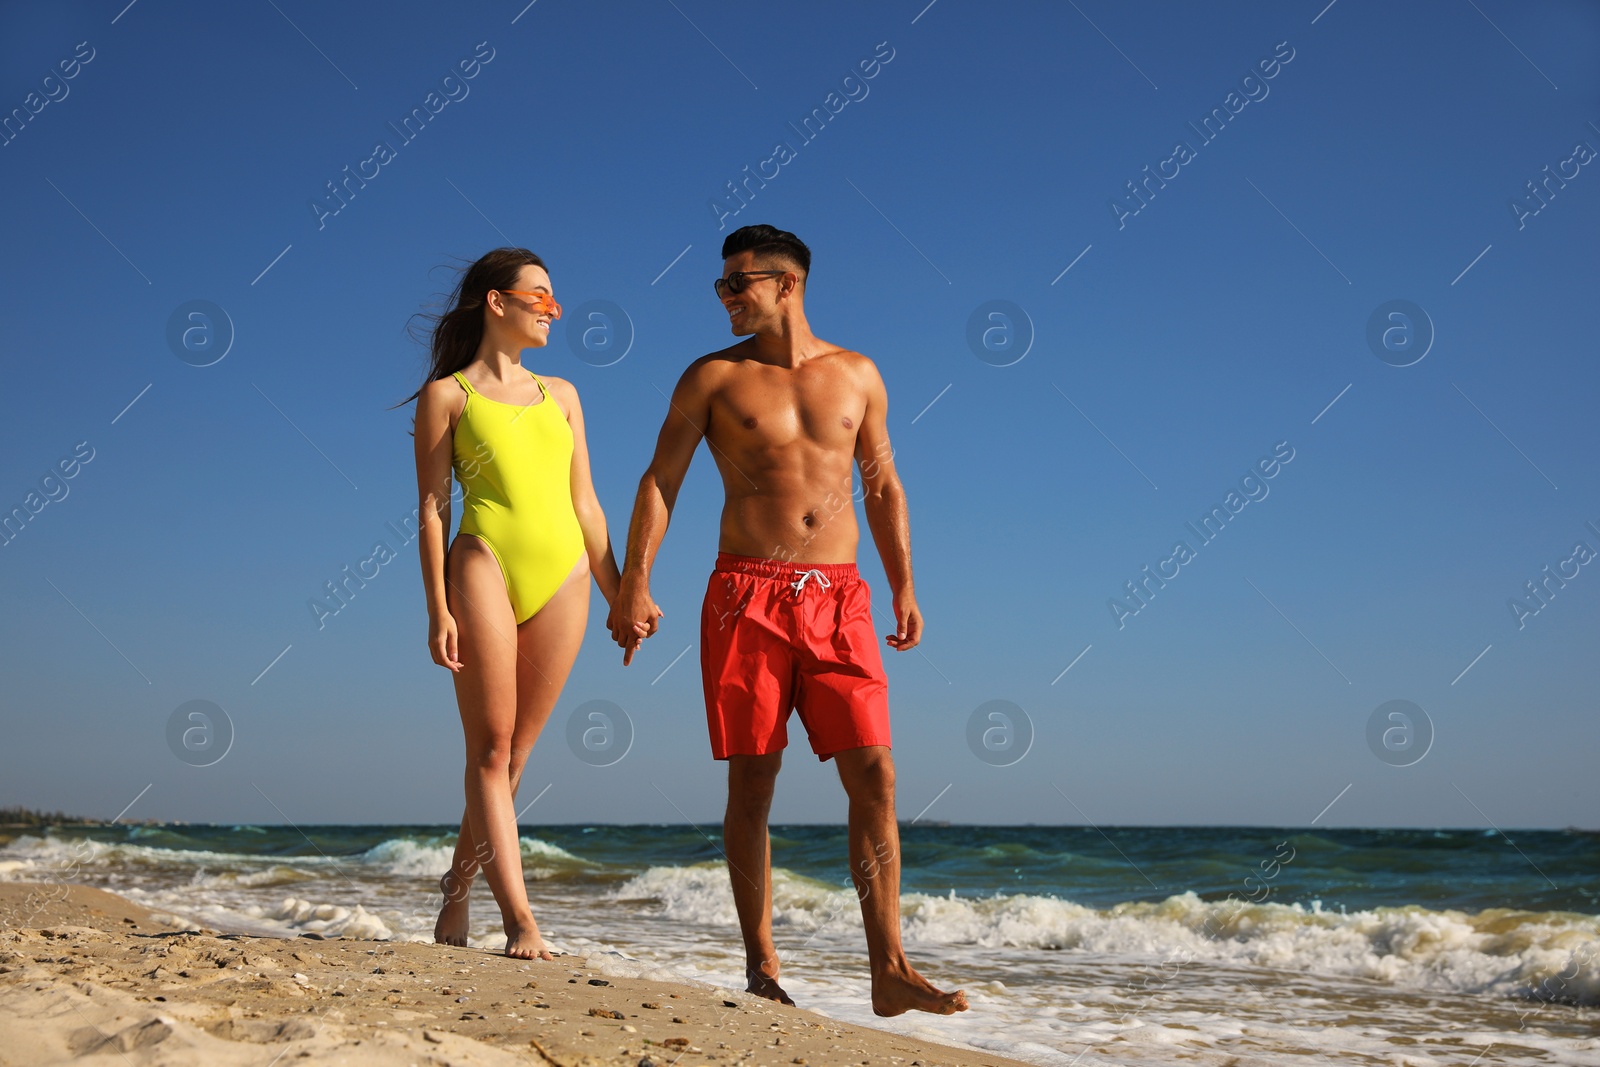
[0, 0, 1600, 827]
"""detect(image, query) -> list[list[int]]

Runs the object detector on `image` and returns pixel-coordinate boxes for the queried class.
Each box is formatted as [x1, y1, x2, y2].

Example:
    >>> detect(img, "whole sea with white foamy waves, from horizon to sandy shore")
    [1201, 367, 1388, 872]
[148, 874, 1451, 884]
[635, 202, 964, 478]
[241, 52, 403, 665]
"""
[0, 824, 1600, 1067]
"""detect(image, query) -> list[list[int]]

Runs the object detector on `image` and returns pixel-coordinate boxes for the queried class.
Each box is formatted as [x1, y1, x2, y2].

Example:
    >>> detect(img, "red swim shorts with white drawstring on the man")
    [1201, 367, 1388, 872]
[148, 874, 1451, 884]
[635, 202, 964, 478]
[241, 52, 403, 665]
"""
[701, 552, 890, 760]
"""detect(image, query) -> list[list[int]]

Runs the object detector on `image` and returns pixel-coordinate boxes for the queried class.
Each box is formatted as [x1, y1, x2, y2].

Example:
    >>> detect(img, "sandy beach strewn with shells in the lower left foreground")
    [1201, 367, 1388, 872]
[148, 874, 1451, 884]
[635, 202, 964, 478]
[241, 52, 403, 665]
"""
[0, 883, 1018, 1067]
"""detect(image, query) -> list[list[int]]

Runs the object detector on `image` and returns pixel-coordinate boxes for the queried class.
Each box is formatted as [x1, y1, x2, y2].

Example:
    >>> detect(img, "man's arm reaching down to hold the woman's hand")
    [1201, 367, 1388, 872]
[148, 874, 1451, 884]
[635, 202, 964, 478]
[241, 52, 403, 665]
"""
[611, 358, 710, 665]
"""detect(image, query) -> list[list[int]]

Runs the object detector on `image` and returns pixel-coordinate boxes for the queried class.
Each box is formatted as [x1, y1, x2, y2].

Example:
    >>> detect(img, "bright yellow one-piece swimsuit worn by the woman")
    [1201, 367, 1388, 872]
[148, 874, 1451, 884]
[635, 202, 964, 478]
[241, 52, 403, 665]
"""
[453, 368, 584, 625]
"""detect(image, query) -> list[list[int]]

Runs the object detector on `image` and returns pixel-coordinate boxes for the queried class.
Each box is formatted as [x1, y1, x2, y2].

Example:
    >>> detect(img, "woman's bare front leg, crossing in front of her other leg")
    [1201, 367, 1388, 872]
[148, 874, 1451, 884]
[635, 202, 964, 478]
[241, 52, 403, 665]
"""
[442, 536, 550, 960]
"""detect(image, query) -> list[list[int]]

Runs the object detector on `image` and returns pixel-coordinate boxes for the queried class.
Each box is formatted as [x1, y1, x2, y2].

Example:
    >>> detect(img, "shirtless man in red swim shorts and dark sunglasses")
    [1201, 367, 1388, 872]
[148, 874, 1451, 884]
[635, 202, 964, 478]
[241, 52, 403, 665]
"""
[610, 226, 966, 1016]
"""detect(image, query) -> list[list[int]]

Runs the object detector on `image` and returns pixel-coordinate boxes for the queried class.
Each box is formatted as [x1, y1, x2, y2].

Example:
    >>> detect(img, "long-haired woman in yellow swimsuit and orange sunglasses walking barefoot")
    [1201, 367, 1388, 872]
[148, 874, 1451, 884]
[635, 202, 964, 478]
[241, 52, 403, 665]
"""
[413, 248, 643, 960]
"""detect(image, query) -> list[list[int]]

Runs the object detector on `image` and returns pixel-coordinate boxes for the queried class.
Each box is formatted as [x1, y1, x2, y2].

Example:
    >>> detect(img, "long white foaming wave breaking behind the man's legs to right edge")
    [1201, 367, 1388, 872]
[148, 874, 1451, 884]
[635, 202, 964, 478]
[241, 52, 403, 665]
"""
[608, 864, 1600, 1005]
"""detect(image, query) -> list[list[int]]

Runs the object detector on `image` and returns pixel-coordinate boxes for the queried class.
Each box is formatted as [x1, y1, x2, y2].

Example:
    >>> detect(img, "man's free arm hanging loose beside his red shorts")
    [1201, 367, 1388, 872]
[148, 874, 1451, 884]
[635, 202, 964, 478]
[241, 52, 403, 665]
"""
[856, 358, 922, 653]
